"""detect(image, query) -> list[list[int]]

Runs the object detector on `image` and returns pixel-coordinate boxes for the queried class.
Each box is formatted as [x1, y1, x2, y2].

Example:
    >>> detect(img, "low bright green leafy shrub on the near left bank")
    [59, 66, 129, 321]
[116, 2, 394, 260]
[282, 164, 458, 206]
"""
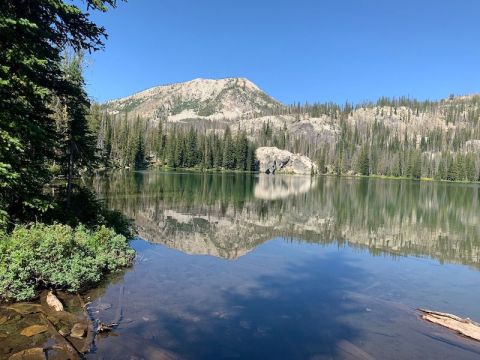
[0, 224, 135, 301]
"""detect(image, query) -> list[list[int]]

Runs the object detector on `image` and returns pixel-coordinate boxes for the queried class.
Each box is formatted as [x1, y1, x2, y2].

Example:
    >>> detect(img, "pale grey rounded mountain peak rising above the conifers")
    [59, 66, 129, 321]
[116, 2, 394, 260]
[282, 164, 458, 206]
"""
[104, 78, 283, 122]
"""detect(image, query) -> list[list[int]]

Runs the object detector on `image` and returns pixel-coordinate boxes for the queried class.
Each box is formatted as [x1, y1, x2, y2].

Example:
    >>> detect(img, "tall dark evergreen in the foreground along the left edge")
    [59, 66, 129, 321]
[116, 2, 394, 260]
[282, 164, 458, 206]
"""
[0, 0, 119, 224]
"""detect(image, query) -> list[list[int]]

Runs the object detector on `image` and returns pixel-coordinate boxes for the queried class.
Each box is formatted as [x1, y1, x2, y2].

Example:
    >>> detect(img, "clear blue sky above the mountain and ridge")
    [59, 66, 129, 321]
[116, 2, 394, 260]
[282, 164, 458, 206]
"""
[86, 0, 480, 103]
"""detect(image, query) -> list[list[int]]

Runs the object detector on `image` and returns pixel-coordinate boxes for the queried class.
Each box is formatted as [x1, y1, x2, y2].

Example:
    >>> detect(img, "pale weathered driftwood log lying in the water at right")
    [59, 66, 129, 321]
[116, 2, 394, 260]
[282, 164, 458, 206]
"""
[418, 309, 480, 341]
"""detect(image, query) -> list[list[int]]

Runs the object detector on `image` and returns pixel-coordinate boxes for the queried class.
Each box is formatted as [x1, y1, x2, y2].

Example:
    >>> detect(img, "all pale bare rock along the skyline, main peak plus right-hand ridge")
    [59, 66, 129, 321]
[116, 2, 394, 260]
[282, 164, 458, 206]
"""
[102, 78, 480, 148]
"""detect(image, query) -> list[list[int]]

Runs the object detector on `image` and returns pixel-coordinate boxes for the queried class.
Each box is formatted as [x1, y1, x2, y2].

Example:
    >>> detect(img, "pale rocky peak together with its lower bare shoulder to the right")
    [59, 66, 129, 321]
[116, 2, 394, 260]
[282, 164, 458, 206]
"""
[102, 78, 340, 146]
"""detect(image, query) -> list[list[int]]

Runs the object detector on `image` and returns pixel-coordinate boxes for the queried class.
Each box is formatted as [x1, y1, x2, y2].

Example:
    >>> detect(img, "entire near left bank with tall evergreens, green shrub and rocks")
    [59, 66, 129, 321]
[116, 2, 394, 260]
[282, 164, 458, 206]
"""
[0, 0, 135, 360]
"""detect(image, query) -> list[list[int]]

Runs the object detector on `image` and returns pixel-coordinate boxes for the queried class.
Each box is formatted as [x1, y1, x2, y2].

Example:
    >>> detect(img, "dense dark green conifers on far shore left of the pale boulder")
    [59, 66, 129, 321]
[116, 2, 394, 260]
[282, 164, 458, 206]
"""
[90, 108, 255, 171]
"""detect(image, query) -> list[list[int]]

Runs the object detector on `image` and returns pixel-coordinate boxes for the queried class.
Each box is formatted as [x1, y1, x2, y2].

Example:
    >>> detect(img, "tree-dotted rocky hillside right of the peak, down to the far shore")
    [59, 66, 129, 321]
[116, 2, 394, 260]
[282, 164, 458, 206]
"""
[255, 96, 480, 181]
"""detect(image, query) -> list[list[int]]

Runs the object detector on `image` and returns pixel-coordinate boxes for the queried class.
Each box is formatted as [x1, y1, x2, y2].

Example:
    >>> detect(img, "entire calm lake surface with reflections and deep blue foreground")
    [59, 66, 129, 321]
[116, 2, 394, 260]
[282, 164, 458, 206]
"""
[88, 171, 480, 359]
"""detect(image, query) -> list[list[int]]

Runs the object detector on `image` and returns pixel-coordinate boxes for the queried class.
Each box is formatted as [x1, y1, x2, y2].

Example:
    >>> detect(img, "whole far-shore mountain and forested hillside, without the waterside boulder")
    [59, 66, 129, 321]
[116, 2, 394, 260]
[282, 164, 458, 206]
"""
[90, 79, 480, 181]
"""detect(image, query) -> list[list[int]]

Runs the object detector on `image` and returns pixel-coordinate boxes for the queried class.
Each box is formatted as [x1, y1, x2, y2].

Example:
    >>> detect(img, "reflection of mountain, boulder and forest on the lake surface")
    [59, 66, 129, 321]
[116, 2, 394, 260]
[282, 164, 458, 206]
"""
[94, 171, 480, 268]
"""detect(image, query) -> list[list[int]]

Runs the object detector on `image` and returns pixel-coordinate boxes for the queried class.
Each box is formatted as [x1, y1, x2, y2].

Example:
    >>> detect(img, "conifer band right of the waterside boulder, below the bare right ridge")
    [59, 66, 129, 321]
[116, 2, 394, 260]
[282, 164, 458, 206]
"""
[316, 116, 479, 181]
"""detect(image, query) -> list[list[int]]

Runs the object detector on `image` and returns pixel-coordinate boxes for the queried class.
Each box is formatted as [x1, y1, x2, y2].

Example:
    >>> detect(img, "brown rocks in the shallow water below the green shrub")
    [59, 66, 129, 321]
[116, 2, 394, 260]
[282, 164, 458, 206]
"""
[0, 291, 95, 360]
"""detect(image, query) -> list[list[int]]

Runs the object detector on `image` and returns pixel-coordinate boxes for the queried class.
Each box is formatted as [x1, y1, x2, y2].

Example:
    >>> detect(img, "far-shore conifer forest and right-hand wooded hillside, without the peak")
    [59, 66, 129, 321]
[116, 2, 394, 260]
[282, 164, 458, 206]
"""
[90, 96, 480, 181]
